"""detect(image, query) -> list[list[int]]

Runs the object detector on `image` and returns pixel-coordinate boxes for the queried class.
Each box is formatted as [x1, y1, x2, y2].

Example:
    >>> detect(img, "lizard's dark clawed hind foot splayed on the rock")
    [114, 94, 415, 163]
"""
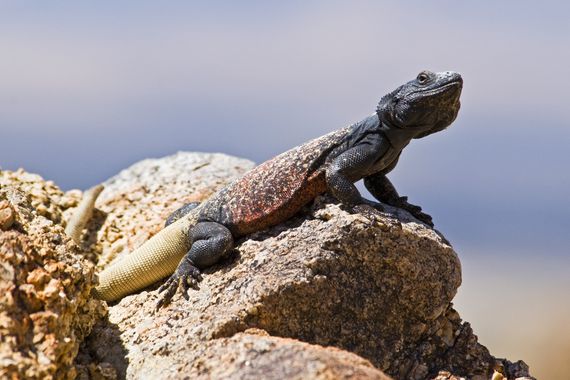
[156, 258, 202, 310]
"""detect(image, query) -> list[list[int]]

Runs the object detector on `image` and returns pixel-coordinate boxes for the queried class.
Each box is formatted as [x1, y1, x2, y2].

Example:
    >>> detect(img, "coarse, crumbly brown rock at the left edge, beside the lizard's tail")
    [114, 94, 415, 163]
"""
[0, 170, 105, 379]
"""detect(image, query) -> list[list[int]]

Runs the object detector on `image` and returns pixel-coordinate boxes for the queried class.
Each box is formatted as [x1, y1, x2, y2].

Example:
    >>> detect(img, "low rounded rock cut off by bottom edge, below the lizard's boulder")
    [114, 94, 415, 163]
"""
[182, 331, 390, 380]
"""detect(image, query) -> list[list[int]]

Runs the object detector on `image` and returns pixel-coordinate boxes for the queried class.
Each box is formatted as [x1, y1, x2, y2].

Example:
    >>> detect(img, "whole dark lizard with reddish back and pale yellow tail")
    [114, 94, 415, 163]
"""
[90, 71, 463, 309]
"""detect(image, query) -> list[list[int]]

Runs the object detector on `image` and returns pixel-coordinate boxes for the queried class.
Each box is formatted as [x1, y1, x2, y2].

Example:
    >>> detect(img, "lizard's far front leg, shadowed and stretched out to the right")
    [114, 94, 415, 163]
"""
[364, 173, 433, 227]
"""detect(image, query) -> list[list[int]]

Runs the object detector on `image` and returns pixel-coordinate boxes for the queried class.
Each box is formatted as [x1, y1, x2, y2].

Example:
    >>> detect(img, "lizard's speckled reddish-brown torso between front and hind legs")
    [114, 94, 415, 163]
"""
[201, 127, 350, 236]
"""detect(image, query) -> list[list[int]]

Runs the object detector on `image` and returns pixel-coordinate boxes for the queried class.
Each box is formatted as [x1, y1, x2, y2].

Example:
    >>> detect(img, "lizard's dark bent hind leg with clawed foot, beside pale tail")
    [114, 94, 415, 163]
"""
[156, 222, 234, 310]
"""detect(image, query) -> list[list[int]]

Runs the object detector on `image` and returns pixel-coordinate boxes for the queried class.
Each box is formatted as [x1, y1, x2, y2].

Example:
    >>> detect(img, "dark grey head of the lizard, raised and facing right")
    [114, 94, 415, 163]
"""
[377, 71, 463, 138]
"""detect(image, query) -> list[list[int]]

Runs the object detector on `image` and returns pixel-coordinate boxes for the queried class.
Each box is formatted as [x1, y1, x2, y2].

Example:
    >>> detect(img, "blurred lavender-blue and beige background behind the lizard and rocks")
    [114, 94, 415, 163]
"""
[0, 0, 570, 379]
